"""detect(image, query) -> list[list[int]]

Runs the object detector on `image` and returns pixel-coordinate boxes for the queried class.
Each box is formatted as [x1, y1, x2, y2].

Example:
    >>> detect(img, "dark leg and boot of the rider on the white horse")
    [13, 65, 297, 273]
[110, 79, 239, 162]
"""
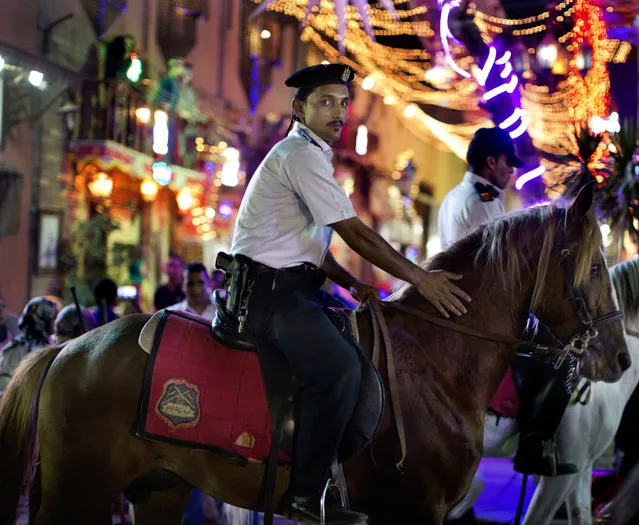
[513, 350, 577, 476]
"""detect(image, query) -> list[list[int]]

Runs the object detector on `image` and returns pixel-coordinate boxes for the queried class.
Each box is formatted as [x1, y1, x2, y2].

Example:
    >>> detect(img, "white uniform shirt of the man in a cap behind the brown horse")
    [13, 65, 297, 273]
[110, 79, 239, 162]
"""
[437, 171, 506, 249]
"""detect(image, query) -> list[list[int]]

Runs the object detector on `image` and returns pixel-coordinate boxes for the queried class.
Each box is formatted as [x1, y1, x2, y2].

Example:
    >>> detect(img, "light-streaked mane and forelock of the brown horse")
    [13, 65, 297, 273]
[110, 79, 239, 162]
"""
[389, 204, 601, 310]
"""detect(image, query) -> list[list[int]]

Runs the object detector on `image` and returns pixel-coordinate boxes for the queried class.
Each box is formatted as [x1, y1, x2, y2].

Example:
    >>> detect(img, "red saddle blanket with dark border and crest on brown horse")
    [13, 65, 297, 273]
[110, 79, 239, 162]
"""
[136, 311, 272, 461]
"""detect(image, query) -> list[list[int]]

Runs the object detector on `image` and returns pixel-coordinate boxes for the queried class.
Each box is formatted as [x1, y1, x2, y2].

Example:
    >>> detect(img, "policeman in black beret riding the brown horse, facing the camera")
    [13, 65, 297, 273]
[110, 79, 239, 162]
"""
[218, 64, 470, 524]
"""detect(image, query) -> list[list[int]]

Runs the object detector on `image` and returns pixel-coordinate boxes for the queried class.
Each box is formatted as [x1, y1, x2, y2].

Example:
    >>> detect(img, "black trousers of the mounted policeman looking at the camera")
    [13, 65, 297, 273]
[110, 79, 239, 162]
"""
[248, 272, 361, 496]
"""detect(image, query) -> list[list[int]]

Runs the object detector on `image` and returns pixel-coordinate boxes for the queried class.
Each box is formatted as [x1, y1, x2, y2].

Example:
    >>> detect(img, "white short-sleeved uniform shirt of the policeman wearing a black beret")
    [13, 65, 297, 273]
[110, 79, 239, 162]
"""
[231, 122, 356, 268]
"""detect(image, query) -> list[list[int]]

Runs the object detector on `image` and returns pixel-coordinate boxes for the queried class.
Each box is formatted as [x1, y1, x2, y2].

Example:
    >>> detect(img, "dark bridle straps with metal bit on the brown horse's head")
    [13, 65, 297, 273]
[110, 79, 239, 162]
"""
[555, 248, 623, 369]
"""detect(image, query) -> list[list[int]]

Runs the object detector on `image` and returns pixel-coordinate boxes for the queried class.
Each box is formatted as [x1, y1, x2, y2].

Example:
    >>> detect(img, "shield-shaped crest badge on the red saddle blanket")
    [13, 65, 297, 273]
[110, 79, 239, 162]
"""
[155, 378, 200, 429]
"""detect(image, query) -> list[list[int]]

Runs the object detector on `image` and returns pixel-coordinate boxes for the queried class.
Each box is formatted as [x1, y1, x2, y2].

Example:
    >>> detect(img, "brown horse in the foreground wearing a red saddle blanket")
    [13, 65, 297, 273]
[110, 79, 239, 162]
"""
[0, 186, 629, 525]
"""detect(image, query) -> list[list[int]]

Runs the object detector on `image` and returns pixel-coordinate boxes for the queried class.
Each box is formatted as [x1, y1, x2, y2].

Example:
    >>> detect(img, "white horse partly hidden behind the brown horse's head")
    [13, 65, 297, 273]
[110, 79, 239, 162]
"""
[448, 258, 639, 525]
